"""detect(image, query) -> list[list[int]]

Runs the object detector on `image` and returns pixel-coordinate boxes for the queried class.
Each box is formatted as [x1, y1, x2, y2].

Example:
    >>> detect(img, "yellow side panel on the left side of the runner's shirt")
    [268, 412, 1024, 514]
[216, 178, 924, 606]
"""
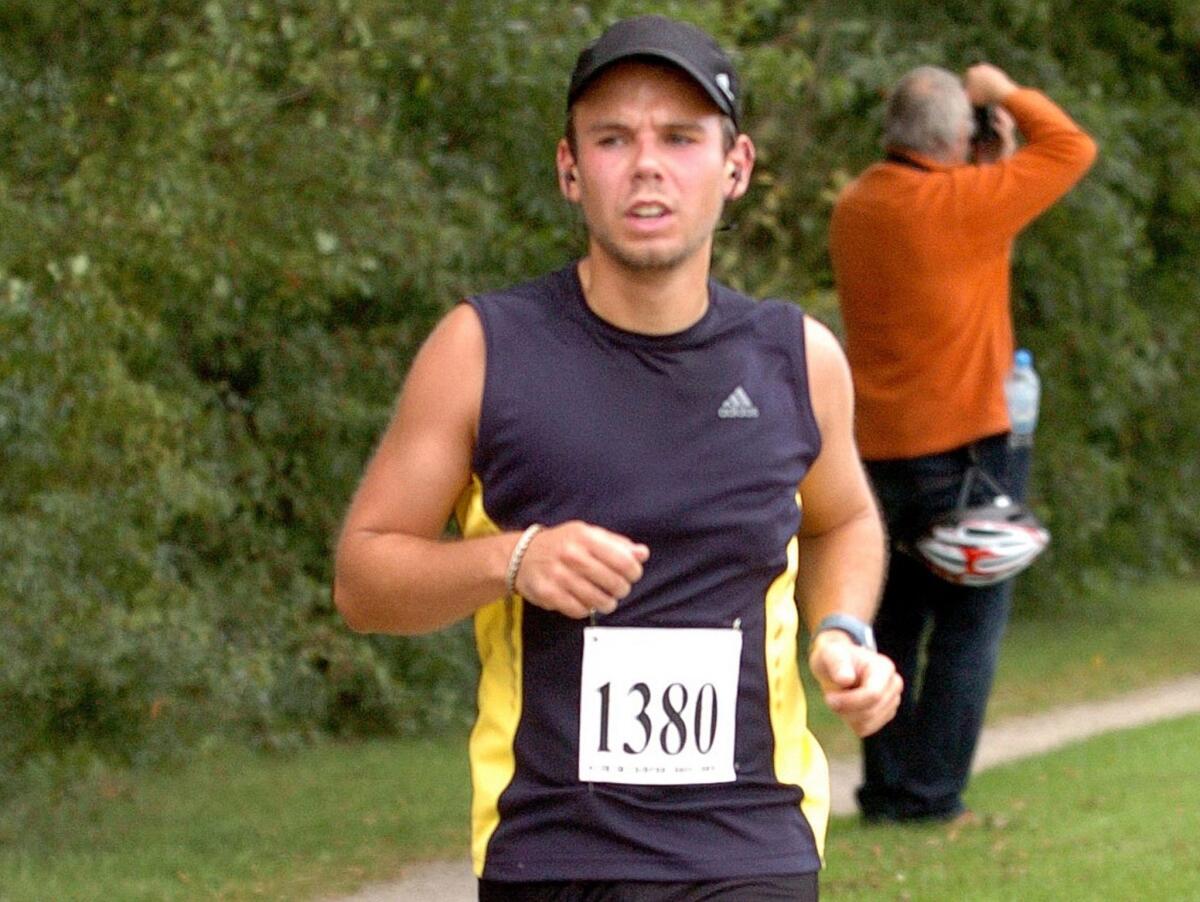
[455, 475, 523, 877]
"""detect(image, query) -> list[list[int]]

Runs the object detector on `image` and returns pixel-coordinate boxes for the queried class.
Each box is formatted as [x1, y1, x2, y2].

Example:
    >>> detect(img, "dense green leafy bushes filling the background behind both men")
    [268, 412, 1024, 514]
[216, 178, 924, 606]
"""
[0, 0, 1200, 774]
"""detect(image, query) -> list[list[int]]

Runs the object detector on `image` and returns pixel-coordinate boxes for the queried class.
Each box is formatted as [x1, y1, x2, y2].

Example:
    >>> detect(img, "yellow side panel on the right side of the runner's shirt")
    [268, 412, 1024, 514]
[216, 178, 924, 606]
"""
[766, 493, 830, 859]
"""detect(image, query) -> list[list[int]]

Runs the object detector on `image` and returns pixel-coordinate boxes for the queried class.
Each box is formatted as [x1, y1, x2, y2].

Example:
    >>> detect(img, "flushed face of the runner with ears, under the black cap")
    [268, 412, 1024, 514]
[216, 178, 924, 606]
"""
[558, 62, 754, 270]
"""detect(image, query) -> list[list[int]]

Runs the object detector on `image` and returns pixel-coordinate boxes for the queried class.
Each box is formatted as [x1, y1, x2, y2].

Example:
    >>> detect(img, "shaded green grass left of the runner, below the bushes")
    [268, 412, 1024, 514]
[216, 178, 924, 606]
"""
[0, 736, 468, 902]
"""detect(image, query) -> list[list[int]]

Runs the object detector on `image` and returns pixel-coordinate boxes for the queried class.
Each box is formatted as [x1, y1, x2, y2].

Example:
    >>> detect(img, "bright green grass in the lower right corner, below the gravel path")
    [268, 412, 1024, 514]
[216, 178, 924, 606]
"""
[822, 717, 1200, 902]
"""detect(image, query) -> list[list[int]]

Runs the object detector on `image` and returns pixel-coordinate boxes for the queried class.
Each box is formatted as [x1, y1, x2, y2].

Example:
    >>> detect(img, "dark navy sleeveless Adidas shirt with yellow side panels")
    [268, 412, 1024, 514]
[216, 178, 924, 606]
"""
[456, 264, 829, 880]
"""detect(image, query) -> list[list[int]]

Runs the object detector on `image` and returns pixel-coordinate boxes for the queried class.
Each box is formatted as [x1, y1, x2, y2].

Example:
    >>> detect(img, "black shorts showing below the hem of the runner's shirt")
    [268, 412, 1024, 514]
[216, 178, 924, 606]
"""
[479, 873, 817, 902]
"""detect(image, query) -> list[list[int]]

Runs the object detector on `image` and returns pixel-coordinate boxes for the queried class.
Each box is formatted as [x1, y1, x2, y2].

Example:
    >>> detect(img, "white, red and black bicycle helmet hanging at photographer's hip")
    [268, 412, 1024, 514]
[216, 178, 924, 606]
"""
[916, 494, 1050, 585]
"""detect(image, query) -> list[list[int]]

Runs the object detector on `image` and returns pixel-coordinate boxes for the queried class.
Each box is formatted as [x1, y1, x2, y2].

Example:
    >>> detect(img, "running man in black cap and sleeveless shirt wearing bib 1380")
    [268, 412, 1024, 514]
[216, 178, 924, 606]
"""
[335, 17, 901, 902]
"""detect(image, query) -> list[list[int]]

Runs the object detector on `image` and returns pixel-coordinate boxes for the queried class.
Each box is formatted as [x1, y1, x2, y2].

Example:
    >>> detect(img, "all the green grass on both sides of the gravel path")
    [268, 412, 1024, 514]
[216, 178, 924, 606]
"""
[0, 583, 1200, 902]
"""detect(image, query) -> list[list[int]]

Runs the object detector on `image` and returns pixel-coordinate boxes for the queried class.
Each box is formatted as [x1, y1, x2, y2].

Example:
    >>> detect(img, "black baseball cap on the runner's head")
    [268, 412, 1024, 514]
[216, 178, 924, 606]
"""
[566, 16, 742, 128]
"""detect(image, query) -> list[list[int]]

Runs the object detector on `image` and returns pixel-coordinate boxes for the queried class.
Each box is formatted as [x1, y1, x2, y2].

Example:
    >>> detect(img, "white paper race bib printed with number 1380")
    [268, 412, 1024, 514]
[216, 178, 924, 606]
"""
[580, 626, 742, 786]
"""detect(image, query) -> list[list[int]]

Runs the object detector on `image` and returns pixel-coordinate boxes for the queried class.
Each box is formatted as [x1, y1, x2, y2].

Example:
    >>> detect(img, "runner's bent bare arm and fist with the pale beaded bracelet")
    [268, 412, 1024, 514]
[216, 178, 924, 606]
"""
[334, 305, 648, 633]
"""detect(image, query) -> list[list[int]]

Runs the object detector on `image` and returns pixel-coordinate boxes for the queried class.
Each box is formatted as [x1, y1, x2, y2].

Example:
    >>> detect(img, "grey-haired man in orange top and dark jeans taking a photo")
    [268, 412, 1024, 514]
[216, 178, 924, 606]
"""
[830, 64, 1096, 820]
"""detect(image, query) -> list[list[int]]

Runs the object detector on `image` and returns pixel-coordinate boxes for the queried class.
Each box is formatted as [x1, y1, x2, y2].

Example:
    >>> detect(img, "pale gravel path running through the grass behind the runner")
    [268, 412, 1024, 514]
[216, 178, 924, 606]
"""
[326, 674, 1200, 902]
